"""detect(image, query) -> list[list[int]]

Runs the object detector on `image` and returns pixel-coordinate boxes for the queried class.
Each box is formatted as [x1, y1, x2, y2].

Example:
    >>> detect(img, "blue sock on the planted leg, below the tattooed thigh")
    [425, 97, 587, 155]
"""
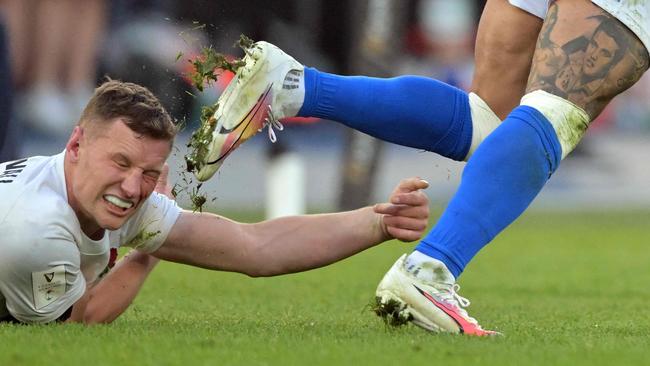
[416, 106, 562, 277]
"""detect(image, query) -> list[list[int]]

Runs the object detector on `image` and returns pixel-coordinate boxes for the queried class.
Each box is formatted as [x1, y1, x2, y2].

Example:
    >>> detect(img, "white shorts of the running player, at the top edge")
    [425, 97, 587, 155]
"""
[508, 0, 650, 50]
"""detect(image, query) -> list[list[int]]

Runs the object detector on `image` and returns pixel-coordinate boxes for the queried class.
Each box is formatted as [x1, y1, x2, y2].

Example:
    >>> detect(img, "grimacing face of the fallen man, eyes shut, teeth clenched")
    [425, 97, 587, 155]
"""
[66, 118, 171, 235]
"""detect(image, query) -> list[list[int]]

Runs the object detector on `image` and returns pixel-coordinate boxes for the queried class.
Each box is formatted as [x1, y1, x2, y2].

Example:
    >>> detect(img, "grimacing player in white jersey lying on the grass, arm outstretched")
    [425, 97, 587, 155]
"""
[0, 81, 429, 323]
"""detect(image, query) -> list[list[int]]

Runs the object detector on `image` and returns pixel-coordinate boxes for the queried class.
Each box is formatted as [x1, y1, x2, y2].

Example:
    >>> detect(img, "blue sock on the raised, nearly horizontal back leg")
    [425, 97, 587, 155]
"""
[298, 68, 472, 160]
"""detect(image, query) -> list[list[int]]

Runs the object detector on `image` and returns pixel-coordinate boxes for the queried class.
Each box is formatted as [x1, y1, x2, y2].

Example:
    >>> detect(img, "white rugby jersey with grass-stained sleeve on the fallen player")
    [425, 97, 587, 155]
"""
[0, 152, 181, 323]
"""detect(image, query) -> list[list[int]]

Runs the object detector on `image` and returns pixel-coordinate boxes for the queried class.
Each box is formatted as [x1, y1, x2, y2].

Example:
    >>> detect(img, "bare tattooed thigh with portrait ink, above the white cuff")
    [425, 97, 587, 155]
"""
[526, 0, 648, 120]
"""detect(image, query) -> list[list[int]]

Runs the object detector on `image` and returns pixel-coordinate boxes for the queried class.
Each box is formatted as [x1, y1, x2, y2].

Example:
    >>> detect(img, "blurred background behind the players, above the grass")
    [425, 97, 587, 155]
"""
[0, 0, 650, 216]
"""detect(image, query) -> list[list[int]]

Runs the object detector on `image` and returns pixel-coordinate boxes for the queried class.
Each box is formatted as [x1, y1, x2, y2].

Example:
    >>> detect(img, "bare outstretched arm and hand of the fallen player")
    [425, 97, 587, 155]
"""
[149, 178, 429, 277]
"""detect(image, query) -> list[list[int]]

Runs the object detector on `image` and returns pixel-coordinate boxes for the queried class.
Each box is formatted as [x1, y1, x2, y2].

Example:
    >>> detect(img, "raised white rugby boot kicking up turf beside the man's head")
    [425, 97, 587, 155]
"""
[188, 42, 304, 181]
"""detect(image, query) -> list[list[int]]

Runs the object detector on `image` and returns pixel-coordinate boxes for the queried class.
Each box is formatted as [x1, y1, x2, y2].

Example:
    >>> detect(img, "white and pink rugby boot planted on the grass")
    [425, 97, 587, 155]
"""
[375, 254, 500, 336]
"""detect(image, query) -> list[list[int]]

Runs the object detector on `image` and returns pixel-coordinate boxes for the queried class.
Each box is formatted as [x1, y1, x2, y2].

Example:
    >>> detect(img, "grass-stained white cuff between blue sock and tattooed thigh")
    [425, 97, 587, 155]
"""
[521, 90, 591, 159]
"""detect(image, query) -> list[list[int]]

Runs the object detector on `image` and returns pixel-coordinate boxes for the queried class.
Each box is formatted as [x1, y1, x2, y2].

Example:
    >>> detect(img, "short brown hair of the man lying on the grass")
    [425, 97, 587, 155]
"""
[79, 79, 177, 140]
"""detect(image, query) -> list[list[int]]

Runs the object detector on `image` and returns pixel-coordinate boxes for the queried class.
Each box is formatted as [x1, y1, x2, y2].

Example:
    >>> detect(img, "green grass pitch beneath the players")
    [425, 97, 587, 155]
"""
[0, 212, 650, 366]
